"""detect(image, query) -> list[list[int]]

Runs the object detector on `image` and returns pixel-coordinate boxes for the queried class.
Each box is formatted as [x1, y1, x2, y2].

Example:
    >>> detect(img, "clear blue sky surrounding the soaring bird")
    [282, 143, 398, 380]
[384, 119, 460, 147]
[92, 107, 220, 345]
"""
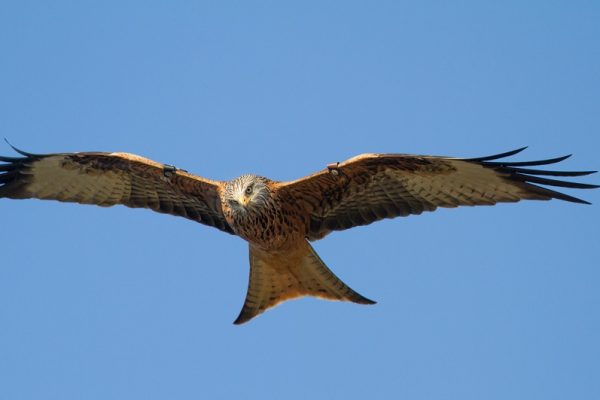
[0, 1, 600, 400]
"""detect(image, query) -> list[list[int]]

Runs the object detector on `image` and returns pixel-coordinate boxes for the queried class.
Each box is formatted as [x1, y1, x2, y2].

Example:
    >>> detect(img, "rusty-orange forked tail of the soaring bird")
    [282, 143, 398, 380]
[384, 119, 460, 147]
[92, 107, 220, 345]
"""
[234, 241, 375, 324]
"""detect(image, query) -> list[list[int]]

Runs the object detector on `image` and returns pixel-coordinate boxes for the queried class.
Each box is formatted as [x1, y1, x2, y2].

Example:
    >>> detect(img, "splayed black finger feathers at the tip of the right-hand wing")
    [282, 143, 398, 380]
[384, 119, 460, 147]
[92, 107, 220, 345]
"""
[456, 147, 600, 204]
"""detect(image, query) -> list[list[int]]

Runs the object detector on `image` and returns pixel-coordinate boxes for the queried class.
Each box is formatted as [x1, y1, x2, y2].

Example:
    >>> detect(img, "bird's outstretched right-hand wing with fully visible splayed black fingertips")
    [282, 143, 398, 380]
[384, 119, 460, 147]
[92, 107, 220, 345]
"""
[278, 148, 599, 240]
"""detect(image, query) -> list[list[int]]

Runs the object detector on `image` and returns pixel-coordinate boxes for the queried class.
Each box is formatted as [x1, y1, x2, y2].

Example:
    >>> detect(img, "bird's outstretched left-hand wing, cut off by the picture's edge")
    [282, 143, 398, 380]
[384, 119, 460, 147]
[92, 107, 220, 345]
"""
[0, 149, 233, 234]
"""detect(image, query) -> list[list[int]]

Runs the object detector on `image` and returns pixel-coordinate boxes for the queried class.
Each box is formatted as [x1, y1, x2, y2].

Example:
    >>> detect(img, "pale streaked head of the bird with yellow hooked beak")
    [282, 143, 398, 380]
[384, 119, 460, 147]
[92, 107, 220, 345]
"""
[224, 175, 270, 212]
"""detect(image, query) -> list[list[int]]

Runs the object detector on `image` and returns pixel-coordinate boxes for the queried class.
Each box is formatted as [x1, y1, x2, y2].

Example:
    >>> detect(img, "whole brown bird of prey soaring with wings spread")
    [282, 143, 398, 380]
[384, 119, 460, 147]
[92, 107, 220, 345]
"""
[0, 146, 600, 324]
